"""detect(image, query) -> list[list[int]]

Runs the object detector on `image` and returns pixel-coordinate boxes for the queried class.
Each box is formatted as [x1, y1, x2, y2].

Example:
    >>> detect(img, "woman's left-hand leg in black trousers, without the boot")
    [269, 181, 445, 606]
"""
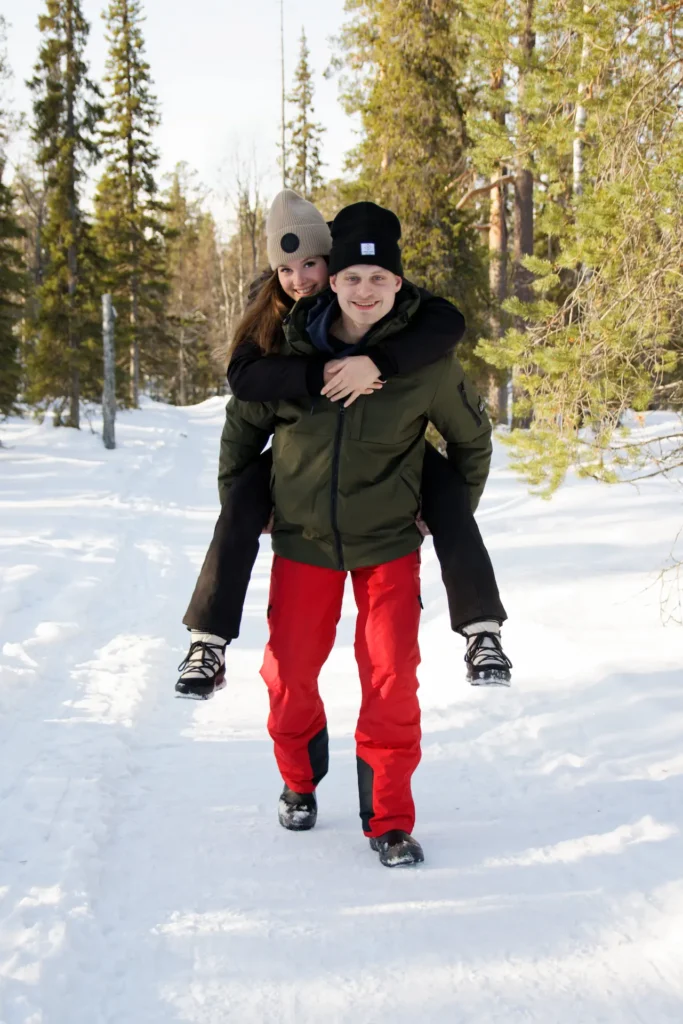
[187, 449, 272, 643]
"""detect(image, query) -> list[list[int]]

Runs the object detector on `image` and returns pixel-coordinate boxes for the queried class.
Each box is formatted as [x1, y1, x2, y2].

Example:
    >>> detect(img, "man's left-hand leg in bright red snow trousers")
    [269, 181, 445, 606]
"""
[261, 555, 346, 794]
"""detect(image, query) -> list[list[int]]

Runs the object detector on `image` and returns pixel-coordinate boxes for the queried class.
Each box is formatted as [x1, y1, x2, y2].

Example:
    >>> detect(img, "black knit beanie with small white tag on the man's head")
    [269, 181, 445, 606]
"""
[330, 203, 403, 278]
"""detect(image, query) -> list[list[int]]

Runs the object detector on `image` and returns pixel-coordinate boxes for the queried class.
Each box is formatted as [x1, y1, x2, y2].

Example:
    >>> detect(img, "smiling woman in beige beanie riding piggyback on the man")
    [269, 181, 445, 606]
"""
[176, 189, 511, 697]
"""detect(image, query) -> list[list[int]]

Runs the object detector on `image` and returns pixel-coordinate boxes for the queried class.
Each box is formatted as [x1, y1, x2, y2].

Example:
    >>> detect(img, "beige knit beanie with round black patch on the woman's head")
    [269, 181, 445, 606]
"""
[265, 188, 332, 270]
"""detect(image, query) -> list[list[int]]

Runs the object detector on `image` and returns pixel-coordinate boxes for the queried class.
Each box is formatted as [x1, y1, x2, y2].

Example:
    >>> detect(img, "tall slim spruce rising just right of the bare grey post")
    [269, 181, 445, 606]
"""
[95, 0, 165, 406]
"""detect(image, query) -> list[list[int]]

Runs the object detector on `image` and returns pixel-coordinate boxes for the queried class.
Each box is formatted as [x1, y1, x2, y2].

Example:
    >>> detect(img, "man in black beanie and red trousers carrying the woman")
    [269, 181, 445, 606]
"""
[218, 197, 505, 867]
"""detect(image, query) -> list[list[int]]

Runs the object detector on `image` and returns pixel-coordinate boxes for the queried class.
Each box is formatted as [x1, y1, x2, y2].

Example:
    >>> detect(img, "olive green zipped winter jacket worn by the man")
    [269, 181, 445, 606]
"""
[218, 286, 492, 569]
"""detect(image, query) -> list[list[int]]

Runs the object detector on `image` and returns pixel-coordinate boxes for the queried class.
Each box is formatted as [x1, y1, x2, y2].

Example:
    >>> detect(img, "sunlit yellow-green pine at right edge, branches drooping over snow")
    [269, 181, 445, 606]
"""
[487, 0, 683, 489]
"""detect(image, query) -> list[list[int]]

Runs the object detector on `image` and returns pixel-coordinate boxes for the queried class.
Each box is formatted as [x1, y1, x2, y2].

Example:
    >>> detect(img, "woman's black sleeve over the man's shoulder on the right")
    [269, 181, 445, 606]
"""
[367, 289, 465, 379]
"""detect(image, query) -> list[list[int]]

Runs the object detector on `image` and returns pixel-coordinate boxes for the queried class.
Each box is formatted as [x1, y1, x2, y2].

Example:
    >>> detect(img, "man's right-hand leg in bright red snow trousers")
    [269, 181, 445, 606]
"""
[351, 551, 421, 839]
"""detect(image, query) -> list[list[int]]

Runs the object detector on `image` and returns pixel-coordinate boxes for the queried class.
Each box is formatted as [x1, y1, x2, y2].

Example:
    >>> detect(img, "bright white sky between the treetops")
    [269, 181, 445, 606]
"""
[0, 0, 354, 230]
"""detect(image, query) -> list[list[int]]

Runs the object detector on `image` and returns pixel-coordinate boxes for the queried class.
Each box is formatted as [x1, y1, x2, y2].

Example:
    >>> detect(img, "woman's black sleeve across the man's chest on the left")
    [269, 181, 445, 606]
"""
[227, 341, 327, 401]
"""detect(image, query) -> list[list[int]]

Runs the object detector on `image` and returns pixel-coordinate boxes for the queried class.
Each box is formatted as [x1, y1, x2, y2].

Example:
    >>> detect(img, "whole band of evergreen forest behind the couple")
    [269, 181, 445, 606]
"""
[0, 0, 683, 493]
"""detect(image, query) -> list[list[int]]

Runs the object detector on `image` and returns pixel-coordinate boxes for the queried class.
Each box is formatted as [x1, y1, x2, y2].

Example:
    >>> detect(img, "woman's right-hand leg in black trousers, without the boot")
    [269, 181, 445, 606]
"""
[422, 443, 508, 632]
